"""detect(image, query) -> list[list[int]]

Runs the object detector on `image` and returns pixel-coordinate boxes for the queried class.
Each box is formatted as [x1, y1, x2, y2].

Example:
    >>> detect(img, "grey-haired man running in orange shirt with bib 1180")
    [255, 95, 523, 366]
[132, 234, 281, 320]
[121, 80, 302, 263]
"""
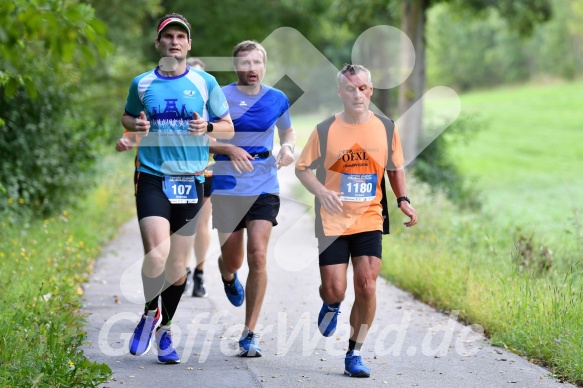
[296, 65, 417, 377]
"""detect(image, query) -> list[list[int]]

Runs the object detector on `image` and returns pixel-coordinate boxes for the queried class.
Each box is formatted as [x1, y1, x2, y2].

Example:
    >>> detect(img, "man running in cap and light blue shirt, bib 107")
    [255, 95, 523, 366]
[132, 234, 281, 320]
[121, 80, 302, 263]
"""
[121, 14, 233, 364]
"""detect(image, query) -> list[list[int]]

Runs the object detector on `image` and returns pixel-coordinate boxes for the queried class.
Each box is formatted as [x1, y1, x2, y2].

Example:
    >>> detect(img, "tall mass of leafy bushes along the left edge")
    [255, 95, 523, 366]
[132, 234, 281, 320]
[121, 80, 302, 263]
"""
[0, 0, 111, 216]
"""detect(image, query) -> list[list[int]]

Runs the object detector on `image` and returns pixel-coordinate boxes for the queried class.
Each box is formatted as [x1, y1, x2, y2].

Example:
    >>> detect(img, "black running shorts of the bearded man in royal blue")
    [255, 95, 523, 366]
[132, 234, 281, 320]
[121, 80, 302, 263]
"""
[211, 194, 280, 233]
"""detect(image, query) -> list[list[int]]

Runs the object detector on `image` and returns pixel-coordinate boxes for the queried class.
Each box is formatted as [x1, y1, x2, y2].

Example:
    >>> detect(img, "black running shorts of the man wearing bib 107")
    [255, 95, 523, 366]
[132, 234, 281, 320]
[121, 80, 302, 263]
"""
[136, 172, 204, 236]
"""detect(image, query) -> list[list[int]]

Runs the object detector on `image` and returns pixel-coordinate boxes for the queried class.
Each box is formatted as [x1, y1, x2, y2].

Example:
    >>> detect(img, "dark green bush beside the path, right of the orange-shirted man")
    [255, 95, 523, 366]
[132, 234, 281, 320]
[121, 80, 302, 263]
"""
[413, 115, 485, 210]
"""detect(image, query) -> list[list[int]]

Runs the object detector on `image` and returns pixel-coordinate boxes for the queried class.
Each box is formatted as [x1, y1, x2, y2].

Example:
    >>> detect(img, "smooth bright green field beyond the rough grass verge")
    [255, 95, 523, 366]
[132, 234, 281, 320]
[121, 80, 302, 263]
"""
[452, 82, 583, 237]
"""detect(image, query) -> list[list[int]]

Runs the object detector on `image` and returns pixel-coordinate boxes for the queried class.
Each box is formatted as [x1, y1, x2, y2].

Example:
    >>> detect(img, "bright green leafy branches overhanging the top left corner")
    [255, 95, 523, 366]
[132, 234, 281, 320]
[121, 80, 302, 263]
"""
[0, 0, 112, 97]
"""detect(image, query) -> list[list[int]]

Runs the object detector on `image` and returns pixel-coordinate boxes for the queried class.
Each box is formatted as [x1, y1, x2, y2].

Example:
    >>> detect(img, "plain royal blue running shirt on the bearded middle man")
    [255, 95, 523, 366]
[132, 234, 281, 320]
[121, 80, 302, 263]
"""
[213, 83, 291, 196]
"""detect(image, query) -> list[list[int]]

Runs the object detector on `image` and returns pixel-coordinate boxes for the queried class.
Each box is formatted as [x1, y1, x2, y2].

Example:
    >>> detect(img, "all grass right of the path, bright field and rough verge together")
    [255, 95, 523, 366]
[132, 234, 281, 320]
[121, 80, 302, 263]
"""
[383, 82, 583, 384]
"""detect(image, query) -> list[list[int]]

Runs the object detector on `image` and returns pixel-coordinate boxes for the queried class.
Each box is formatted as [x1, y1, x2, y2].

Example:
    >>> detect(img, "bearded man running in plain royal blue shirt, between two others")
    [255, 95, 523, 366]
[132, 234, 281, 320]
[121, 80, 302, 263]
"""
[211, 41, 295, 357]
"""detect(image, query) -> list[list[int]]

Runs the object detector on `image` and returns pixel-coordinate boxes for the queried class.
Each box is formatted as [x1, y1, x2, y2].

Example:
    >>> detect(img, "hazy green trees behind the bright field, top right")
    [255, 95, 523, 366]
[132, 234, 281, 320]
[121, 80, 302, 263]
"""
[427, 0, 583, 90]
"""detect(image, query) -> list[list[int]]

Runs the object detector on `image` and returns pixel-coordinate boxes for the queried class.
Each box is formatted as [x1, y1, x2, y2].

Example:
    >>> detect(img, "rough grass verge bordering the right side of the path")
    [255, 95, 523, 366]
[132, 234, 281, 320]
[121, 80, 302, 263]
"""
[382, 178, 583, 384]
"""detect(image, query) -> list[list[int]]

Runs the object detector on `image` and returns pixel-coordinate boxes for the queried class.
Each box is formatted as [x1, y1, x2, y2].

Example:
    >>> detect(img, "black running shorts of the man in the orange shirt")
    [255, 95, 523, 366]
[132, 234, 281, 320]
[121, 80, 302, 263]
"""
[318, 230, 383, 267]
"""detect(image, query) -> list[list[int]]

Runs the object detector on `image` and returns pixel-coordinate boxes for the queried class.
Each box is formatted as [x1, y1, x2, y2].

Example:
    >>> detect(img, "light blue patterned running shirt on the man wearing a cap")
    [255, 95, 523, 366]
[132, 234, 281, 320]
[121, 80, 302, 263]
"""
[125, 66, 229, 182]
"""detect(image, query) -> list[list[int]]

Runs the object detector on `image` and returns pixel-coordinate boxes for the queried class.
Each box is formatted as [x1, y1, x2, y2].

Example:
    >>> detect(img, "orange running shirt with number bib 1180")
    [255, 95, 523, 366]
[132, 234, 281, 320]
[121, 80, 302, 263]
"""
[296, 112, 404, 236]
